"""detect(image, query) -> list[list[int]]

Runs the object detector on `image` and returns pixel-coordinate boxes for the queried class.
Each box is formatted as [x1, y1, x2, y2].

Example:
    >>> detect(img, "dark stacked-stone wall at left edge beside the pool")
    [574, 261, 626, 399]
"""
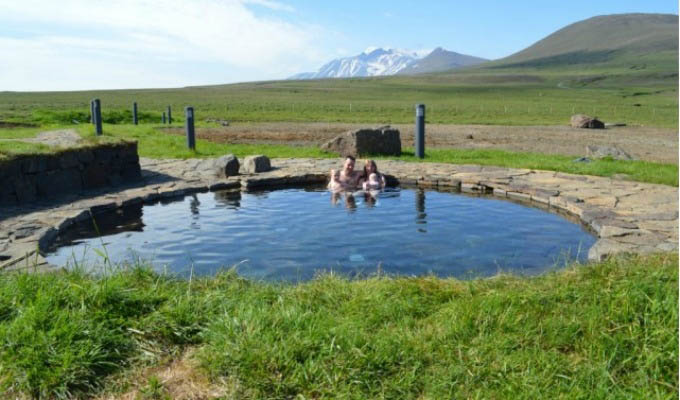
[0, 142, 141, 204]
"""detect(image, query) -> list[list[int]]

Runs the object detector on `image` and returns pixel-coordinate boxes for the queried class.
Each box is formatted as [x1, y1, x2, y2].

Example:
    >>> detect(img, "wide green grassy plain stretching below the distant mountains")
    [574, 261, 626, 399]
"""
[0, 65, 678, 128]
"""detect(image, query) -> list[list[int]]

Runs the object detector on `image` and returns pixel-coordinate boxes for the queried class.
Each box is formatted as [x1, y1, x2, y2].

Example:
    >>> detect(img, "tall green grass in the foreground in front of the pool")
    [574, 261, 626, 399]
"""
[0, 254, 678, 399]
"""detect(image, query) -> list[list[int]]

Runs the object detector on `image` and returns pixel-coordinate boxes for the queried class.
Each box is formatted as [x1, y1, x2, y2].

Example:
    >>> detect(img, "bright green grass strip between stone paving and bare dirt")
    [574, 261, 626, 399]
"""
[0, 125, 678, 186]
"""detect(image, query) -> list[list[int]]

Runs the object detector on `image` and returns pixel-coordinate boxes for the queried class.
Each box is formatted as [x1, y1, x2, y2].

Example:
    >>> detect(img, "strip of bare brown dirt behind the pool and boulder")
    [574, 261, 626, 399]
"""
[159, 122, 678, 164]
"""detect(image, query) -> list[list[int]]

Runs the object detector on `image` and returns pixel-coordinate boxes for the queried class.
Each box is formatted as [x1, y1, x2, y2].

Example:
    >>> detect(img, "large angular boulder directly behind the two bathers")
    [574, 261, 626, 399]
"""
[321, 126, 401, 157]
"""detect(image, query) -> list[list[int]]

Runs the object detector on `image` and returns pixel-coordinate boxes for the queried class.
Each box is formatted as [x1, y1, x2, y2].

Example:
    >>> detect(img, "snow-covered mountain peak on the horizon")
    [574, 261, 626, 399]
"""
[289, 48, 419, 79]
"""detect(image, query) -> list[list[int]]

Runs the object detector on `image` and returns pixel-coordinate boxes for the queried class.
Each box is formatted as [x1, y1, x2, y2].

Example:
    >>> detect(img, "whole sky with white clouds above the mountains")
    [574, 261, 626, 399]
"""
[0, 0, 678, 91]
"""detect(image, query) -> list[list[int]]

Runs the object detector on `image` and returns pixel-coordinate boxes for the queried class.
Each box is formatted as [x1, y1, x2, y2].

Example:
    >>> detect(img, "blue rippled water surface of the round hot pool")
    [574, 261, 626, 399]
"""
[46, 189, 595, 281]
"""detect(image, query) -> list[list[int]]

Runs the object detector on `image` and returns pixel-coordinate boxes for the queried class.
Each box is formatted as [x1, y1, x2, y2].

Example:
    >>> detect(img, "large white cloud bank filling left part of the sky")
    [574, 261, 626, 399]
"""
[0, 0, 325, 90]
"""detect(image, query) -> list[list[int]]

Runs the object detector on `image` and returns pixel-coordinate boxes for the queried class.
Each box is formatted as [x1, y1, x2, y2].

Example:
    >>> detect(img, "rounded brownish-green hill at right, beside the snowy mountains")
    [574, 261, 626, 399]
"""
[485, 14, 678, 68]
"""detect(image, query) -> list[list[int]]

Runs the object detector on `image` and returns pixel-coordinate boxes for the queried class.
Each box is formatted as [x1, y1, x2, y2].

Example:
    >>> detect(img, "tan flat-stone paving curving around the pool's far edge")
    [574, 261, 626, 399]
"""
[0, 158, 678, 271]
